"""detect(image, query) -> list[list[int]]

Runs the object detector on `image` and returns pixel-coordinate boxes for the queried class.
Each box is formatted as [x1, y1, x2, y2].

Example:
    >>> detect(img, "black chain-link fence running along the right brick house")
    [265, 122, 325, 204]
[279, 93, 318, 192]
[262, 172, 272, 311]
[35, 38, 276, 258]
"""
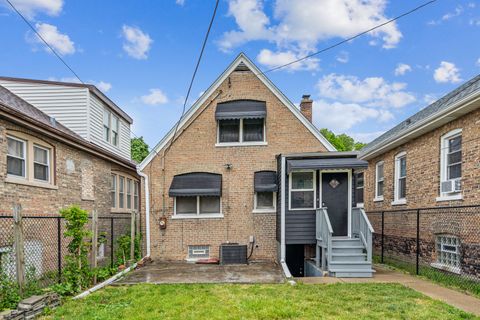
[367, 205, 480, 296]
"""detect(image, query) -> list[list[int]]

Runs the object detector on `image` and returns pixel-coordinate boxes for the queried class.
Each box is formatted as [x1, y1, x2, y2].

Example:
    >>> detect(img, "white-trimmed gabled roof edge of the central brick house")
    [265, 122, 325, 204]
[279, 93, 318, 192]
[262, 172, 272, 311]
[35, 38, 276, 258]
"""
[139, 53, 336, 170]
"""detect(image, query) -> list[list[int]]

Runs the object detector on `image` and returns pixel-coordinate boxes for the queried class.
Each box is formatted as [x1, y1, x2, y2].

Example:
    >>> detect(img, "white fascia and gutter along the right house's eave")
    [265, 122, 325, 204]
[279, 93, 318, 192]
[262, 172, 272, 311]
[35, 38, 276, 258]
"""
[359, 91, 480, 160]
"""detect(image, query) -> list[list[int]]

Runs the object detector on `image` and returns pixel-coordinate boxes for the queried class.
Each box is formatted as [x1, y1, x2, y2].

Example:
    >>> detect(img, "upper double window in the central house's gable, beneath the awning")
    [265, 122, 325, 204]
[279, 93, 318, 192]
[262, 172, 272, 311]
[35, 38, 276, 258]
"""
[218, 118, 265, 143]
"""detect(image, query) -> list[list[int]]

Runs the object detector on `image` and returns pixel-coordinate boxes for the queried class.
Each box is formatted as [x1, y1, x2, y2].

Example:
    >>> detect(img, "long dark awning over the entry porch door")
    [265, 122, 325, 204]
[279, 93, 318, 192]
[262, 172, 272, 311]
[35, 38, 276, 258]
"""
[287, 158, 368, 173]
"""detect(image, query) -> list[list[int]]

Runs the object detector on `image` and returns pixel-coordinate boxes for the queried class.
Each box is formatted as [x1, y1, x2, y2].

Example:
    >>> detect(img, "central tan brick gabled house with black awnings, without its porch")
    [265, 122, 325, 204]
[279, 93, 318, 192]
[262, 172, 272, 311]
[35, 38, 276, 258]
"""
[140, 54, 335, 260]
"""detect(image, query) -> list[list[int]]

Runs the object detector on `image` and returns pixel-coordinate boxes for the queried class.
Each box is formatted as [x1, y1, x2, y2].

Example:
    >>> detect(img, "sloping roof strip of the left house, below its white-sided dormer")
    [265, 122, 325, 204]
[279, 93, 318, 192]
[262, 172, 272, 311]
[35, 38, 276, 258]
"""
[0, 85, 135, 170]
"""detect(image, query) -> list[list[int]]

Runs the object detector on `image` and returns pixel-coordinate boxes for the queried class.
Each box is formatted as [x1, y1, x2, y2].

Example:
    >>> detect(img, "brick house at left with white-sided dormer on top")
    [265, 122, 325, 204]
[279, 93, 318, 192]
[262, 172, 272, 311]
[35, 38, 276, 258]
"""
[0, 78, 140, 273]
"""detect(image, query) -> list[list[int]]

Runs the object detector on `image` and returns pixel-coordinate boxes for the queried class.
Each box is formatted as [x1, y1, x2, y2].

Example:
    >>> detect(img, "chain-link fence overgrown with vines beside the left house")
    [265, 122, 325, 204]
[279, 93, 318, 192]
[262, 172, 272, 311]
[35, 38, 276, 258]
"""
[0, 214, 132, 287]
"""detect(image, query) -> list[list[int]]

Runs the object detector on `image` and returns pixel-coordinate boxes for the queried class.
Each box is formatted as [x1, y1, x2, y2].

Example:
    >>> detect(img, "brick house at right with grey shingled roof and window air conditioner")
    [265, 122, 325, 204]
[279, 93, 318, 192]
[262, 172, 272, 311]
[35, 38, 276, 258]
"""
[359, 76, 480, 276]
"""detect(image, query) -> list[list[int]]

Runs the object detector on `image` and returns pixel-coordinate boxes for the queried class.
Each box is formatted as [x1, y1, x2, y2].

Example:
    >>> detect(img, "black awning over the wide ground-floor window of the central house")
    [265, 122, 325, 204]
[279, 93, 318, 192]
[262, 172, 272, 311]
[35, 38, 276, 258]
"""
[168, 172, 222, 197]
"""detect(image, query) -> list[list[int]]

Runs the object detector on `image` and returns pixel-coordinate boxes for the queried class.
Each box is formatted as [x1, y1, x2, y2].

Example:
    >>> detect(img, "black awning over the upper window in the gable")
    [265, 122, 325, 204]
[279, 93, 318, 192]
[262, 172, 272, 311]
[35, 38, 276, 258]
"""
[215, 100, 267, 120]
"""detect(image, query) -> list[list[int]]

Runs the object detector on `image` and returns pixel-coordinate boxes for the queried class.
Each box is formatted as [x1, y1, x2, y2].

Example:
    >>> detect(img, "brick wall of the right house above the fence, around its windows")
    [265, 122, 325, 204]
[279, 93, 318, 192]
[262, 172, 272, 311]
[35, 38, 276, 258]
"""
[365, 110, 480, 211]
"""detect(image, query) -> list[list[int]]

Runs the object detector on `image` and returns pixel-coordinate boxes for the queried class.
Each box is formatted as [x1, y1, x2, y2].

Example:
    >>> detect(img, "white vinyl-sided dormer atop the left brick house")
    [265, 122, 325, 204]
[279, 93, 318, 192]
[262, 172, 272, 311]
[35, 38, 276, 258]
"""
[0, 78, 130, 159]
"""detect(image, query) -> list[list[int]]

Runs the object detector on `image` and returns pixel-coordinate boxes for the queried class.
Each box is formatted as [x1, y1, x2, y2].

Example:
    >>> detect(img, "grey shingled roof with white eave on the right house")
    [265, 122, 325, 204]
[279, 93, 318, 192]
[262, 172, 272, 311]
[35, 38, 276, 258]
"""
[359, 75, 480, 159]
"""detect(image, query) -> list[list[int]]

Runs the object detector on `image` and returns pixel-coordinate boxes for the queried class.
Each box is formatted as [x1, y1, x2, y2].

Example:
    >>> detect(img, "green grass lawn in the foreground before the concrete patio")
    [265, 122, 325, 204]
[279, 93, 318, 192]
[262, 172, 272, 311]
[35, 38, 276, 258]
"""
[47, 283, 475, 320]
